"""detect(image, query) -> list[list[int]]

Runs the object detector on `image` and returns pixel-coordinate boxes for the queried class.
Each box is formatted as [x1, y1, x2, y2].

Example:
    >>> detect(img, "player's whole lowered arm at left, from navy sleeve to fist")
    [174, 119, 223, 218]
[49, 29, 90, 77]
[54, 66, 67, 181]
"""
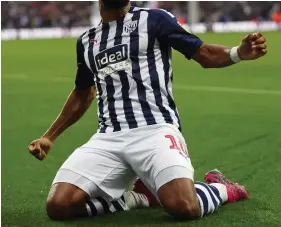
[28, 37, 96, 160]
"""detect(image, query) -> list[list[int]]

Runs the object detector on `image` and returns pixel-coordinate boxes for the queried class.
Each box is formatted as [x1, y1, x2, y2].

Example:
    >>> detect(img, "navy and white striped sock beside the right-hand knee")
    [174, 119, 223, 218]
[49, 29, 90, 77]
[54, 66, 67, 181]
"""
[194, 182, 225, 217]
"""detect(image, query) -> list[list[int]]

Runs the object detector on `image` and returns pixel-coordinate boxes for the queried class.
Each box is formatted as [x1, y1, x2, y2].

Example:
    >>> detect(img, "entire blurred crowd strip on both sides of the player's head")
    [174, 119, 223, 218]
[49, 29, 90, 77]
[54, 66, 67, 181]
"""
[1, 1, 281, 29]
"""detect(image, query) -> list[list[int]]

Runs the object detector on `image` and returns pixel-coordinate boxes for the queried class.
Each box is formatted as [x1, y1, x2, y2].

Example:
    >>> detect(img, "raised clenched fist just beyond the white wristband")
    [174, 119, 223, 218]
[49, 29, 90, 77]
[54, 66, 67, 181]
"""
[238, 32, 267, 60]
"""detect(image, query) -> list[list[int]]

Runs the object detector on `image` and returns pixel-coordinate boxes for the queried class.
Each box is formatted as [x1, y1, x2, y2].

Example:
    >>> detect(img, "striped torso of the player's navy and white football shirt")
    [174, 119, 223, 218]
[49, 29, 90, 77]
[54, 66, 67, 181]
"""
[76, 7, 199, 133]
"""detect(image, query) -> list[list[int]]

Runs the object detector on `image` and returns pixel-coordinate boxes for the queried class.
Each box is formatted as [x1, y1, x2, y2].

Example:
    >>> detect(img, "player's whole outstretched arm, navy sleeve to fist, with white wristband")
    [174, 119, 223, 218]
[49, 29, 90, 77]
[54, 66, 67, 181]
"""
[156, 10, 267, 68]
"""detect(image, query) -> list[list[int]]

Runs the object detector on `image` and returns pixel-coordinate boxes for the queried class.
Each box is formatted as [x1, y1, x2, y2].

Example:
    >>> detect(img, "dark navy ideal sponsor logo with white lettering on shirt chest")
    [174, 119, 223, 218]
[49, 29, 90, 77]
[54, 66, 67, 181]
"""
[95, 44, 128, 70]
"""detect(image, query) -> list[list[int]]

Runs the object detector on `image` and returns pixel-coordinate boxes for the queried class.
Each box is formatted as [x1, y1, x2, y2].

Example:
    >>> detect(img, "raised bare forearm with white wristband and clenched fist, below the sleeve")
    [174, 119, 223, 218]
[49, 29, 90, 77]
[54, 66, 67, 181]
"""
[192, 32, 267, 68]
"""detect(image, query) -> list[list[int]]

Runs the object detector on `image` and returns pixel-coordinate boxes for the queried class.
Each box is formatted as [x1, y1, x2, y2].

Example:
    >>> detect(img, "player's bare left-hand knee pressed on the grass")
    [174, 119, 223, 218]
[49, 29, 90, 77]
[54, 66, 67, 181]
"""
[46, 192, 83, 220]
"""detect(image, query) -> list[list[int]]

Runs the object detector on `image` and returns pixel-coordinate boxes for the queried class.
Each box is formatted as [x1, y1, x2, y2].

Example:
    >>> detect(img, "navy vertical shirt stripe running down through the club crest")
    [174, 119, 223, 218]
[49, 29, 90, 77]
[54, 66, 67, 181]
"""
[130, 12, 156, 125]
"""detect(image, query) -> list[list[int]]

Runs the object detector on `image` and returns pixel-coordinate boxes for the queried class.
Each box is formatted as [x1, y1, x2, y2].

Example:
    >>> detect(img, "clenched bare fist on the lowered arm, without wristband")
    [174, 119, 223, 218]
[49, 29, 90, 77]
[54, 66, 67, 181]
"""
[27, 138, 53, 161]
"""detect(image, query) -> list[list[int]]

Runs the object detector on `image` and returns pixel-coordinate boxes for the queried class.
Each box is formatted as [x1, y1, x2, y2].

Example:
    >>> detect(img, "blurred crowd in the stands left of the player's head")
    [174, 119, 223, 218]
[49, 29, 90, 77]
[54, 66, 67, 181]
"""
[1, 1, 94, 29]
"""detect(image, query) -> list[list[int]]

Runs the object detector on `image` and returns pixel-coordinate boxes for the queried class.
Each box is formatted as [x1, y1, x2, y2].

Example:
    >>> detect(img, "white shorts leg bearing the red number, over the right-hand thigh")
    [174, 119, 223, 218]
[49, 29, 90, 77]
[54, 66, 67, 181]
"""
[124, 125, 194, 195]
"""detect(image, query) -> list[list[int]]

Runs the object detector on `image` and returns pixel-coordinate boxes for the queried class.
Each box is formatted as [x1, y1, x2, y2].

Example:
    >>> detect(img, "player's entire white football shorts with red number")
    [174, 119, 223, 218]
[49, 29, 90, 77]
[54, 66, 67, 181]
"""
[53, 124, 194, 199]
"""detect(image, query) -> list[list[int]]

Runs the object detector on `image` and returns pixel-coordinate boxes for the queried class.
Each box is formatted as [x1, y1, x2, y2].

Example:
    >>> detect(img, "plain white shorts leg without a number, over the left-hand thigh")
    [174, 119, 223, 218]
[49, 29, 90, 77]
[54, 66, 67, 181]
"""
[53, 140, 135, 199]
